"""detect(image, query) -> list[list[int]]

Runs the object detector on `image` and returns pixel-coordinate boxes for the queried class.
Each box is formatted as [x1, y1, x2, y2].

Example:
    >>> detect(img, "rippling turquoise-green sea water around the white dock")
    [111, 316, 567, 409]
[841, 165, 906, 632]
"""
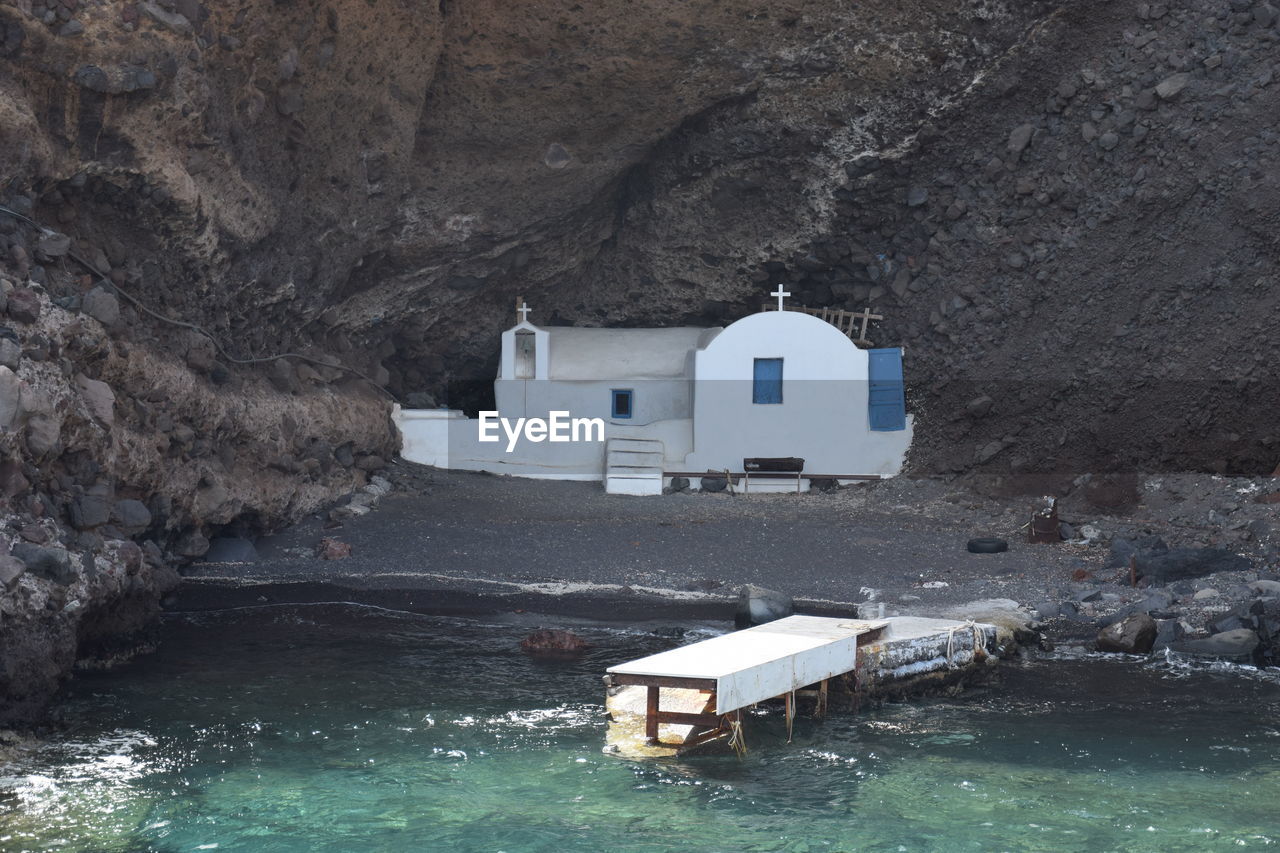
[0, 607, 1280, 853]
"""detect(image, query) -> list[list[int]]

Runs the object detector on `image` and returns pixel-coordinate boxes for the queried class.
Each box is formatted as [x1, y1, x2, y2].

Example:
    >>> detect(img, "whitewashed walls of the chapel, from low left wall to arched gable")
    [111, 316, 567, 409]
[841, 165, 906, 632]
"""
[396, 311, 914, 491]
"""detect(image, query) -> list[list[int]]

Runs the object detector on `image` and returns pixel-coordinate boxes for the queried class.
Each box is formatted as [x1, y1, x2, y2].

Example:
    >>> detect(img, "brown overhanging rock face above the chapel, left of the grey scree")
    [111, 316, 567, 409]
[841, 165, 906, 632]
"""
[0, 0, 1048, 392]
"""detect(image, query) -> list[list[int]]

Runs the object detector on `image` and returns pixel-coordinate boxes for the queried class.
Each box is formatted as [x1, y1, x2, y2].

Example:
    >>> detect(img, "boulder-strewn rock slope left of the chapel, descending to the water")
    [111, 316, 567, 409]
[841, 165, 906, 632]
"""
[0, 278, 394, 725]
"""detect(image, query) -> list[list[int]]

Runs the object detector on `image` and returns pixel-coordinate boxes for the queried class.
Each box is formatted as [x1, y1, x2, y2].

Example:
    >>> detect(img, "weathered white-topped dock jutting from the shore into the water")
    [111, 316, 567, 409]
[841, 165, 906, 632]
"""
[605, 616, 1000, 757]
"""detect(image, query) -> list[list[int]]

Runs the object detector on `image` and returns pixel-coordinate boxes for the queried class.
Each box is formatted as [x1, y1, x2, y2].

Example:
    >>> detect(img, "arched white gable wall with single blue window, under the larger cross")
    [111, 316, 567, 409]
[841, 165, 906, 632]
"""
[685, 311, 913, 476]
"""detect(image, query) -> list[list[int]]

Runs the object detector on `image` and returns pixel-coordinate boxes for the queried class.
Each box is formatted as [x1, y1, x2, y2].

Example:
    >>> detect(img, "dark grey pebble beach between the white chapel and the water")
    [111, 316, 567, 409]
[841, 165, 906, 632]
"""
[5, 462, 1280, 724]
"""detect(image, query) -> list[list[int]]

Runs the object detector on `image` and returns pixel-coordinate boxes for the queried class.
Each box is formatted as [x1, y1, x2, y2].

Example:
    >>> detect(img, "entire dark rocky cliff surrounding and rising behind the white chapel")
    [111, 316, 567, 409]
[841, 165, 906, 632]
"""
[0, 0, 1280, 717]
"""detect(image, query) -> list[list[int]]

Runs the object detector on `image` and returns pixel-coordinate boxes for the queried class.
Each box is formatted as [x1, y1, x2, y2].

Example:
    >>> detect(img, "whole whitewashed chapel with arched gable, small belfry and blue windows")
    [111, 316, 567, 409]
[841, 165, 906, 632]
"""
[396, 293, 913, 494]
